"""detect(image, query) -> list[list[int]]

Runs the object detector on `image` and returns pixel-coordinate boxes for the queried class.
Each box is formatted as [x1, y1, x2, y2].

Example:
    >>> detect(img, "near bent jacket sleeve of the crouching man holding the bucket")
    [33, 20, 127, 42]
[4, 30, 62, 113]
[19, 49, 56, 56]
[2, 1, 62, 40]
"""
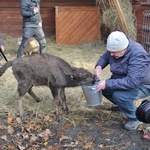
[106, 53, 149, 90]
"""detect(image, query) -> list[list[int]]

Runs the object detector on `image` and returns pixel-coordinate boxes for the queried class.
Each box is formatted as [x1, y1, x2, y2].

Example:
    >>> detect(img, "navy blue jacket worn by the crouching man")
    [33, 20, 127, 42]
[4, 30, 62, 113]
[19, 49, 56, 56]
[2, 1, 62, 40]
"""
[96, 38, 150, 90]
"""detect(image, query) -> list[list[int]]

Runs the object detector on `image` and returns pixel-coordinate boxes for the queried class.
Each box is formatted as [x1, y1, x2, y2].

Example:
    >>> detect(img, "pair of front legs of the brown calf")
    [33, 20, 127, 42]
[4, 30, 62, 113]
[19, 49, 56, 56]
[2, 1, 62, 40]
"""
[51, 87, 68, 122]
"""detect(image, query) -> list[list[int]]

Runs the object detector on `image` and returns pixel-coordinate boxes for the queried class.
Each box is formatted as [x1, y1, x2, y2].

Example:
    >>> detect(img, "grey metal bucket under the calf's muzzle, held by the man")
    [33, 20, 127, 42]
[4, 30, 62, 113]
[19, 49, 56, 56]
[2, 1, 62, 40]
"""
[82, 85, 102, 106]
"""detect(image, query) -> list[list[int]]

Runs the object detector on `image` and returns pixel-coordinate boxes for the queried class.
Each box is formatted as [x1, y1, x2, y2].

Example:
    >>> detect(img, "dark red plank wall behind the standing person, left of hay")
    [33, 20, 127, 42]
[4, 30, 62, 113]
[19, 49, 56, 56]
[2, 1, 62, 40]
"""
[0, 0, 95, 37]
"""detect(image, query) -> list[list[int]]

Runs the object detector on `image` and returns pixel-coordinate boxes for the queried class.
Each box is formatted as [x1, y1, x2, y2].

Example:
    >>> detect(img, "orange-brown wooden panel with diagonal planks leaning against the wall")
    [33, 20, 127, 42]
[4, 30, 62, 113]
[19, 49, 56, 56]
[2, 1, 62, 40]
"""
[55, 6, 100, 45]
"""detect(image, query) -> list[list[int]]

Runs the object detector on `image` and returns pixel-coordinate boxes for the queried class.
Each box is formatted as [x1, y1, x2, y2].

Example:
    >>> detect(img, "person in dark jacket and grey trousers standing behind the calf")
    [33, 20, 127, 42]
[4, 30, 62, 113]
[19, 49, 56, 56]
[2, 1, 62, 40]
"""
[17, 0, 46, 58]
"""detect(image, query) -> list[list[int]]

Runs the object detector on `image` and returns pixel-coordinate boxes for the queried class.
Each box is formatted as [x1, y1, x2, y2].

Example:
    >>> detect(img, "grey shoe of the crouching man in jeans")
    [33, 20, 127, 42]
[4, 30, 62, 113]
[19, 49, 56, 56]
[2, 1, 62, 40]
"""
[124, 120, 142, 131]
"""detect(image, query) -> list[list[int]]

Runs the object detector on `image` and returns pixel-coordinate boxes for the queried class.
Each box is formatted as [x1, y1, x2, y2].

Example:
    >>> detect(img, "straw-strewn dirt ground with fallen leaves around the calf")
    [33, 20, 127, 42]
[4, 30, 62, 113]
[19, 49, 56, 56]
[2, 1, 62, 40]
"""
[0, 35, 150, 150]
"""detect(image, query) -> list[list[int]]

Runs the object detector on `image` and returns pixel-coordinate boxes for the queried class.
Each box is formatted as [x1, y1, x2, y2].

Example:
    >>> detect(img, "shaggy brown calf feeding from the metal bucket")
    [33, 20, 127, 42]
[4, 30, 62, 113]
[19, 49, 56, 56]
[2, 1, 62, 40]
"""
[0, 53, 94, 121]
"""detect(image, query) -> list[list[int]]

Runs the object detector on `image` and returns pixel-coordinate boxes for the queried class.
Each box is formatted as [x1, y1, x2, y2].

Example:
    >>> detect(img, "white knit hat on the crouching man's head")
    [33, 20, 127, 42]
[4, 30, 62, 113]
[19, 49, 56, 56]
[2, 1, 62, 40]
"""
[106, 31, 129, 52]
